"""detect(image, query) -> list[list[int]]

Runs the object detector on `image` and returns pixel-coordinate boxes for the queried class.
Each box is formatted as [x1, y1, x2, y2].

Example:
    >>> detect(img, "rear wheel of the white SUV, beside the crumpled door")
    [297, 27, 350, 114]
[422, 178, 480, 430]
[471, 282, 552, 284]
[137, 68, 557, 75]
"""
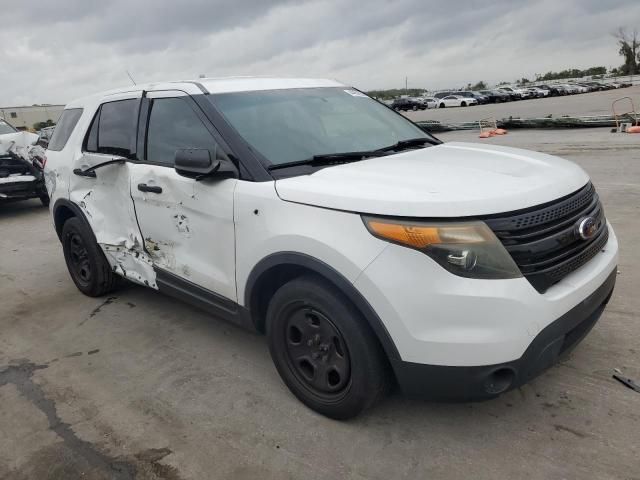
[62, 217, 121, 297]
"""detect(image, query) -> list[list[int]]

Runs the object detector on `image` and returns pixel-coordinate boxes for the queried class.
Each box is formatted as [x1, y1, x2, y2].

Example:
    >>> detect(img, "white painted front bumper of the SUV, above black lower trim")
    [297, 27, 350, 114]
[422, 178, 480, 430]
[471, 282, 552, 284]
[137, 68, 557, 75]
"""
[354, 225, 618, 367]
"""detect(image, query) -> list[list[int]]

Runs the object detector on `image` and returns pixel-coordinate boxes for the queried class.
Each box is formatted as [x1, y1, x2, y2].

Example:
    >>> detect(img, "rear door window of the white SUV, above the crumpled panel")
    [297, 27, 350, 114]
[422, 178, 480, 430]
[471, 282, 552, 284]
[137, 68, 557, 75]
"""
[85, 99, 139, 157]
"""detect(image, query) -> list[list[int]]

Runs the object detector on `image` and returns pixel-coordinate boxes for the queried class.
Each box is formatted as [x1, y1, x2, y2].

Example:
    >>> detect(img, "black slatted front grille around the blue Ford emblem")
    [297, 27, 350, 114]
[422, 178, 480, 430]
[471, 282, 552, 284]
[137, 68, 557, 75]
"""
[485, 183, 609, 293]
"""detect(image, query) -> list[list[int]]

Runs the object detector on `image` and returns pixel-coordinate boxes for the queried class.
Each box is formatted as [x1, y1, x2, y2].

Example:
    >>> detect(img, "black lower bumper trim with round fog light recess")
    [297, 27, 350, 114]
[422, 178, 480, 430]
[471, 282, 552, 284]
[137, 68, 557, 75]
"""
[391, 269, 617, 401]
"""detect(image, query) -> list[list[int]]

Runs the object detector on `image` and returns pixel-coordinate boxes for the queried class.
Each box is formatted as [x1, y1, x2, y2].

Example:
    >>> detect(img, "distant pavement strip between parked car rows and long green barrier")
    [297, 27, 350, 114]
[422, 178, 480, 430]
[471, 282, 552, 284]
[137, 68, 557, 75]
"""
[405, 85, 640, 122]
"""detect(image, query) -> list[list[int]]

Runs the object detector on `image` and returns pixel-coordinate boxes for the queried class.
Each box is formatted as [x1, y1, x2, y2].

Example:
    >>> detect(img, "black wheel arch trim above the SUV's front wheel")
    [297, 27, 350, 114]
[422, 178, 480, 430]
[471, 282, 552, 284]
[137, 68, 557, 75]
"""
[244, 252, 400, 360]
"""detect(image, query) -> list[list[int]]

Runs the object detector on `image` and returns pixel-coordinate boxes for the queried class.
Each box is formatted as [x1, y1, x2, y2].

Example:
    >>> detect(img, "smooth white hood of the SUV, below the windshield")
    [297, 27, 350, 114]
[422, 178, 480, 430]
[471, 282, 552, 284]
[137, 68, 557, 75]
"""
[276, 142, 589, 217]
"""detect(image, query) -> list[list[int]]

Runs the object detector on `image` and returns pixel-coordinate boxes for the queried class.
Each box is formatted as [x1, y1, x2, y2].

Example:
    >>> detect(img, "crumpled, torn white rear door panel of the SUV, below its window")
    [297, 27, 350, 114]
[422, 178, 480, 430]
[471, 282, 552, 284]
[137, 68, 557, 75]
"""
[70, 153, 158, 289]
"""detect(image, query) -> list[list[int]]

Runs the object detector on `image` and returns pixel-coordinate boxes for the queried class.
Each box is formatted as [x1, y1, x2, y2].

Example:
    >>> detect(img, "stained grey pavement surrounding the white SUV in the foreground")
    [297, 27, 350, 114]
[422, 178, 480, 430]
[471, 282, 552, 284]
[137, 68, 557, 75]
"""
[0, 125, 640, 480]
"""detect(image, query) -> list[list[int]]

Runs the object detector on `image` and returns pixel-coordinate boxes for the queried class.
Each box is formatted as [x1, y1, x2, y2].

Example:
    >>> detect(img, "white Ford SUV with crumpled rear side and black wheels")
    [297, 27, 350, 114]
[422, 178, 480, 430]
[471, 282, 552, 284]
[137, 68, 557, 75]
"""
[46, 78, 618, 418]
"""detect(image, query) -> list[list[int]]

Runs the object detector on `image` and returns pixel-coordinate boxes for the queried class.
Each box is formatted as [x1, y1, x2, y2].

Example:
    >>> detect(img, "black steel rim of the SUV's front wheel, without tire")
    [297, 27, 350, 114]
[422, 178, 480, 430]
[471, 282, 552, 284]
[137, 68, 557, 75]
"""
[285, 307, 351, 396]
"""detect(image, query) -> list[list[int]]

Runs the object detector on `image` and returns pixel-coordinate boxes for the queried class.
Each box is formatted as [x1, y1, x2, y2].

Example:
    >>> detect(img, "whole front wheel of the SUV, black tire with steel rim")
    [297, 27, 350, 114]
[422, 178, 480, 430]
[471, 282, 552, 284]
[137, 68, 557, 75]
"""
[266, 275, 389, 420]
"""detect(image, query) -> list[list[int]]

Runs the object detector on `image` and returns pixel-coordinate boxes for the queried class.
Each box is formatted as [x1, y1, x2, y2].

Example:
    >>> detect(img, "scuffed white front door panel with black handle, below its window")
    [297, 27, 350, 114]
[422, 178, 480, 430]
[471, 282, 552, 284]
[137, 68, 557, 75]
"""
[130, 164, 237, 301]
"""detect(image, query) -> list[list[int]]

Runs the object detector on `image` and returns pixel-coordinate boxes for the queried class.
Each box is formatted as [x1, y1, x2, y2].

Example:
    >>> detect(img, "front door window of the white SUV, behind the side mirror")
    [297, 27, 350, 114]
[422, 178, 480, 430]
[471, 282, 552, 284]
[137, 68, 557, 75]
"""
[145, 98, 223, 166]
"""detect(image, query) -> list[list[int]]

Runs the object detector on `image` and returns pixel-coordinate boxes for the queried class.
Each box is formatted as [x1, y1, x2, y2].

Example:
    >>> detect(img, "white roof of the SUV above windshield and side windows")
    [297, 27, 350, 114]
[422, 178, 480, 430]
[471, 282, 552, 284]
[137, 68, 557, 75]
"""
[67, 77, 345, 108]
